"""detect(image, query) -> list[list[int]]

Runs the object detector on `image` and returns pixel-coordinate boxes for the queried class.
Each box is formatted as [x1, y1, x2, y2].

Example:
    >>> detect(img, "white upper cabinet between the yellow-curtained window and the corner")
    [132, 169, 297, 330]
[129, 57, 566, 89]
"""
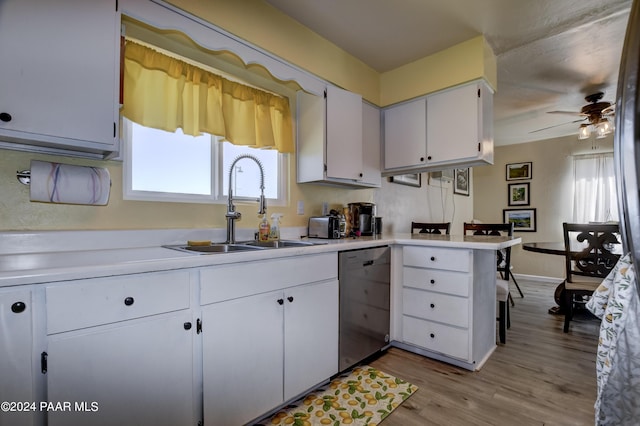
[297, 86, 380, 187]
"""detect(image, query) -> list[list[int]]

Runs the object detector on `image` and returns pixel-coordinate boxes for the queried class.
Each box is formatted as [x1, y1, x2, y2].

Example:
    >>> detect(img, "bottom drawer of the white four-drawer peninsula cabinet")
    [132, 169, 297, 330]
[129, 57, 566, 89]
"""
[402, 316, 469, 360]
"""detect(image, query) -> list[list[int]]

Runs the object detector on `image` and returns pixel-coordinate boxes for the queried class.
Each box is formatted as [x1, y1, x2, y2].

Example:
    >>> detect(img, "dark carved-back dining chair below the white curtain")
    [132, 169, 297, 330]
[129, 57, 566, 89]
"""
[562, 222, 620, 333]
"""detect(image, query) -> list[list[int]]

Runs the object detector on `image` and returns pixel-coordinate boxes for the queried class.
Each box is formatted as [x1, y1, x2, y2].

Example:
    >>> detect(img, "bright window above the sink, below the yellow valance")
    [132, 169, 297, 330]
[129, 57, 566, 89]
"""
[123, 119, 289, 205]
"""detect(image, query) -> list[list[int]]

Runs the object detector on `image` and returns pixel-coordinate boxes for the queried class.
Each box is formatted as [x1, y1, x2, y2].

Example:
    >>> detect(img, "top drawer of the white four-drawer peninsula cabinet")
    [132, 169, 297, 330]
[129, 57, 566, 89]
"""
[402, 246, 471, 272]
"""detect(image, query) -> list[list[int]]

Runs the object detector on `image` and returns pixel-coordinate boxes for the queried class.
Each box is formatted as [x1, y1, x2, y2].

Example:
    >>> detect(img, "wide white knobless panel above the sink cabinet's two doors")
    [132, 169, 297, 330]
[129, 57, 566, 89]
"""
[200, 253, 338, 305]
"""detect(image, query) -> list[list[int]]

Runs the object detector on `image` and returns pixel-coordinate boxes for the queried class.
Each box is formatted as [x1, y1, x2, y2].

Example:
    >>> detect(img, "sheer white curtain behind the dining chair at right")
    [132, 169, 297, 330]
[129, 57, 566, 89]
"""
[573, 153, 618, 223]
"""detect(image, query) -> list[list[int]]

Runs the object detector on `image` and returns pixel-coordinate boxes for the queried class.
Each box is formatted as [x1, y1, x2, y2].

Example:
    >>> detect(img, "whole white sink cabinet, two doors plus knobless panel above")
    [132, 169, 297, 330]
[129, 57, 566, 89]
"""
[201, 253, 338, 426]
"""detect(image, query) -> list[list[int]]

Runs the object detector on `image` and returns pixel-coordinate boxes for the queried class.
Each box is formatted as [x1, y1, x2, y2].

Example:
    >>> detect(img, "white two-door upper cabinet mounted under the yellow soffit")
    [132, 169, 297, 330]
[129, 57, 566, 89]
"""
[383, 81, 493, 175]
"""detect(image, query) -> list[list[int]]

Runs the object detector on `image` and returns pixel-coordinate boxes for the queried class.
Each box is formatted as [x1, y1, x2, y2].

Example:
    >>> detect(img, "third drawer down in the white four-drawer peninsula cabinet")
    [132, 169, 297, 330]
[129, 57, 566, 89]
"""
[402, 288, 469, 328]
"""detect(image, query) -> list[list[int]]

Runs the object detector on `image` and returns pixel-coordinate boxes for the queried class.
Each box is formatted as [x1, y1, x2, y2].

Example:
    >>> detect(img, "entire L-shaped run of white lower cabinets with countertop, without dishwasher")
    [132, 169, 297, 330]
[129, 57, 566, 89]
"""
[0, 231, 520, 425]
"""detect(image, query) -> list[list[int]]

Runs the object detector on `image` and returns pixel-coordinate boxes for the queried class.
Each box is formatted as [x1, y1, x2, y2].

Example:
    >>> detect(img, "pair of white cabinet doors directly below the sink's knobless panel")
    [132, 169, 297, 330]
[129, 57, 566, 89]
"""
[202, 280, 338, 425]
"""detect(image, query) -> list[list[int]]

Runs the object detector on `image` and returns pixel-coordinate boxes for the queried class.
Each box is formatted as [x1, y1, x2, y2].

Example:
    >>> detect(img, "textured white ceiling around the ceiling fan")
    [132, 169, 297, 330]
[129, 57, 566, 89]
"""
[264, 0, 632, 145]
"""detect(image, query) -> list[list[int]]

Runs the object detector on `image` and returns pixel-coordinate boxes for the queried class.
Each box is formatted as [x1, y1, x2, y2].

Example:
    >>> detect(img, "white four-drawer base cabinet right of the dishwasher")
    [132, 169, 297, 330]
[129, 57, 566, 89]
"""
[401, 246, 496, 370]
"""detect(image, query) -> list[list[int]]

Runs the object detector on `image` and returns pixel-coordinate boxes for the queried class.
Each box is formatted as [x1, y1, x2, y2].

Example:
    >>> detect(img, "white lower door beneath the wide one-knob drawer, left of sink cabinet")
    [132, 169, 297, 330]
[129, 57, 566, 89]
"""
[47, 311, 196, 426]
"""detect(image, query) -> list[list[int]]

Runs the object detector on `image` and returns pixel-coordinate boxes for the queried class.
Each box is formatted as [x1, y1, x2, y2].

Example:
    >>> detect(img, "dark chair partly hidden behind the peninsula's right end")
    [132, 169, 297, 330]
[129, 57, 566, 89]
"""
[464, 222, 520, 344]
